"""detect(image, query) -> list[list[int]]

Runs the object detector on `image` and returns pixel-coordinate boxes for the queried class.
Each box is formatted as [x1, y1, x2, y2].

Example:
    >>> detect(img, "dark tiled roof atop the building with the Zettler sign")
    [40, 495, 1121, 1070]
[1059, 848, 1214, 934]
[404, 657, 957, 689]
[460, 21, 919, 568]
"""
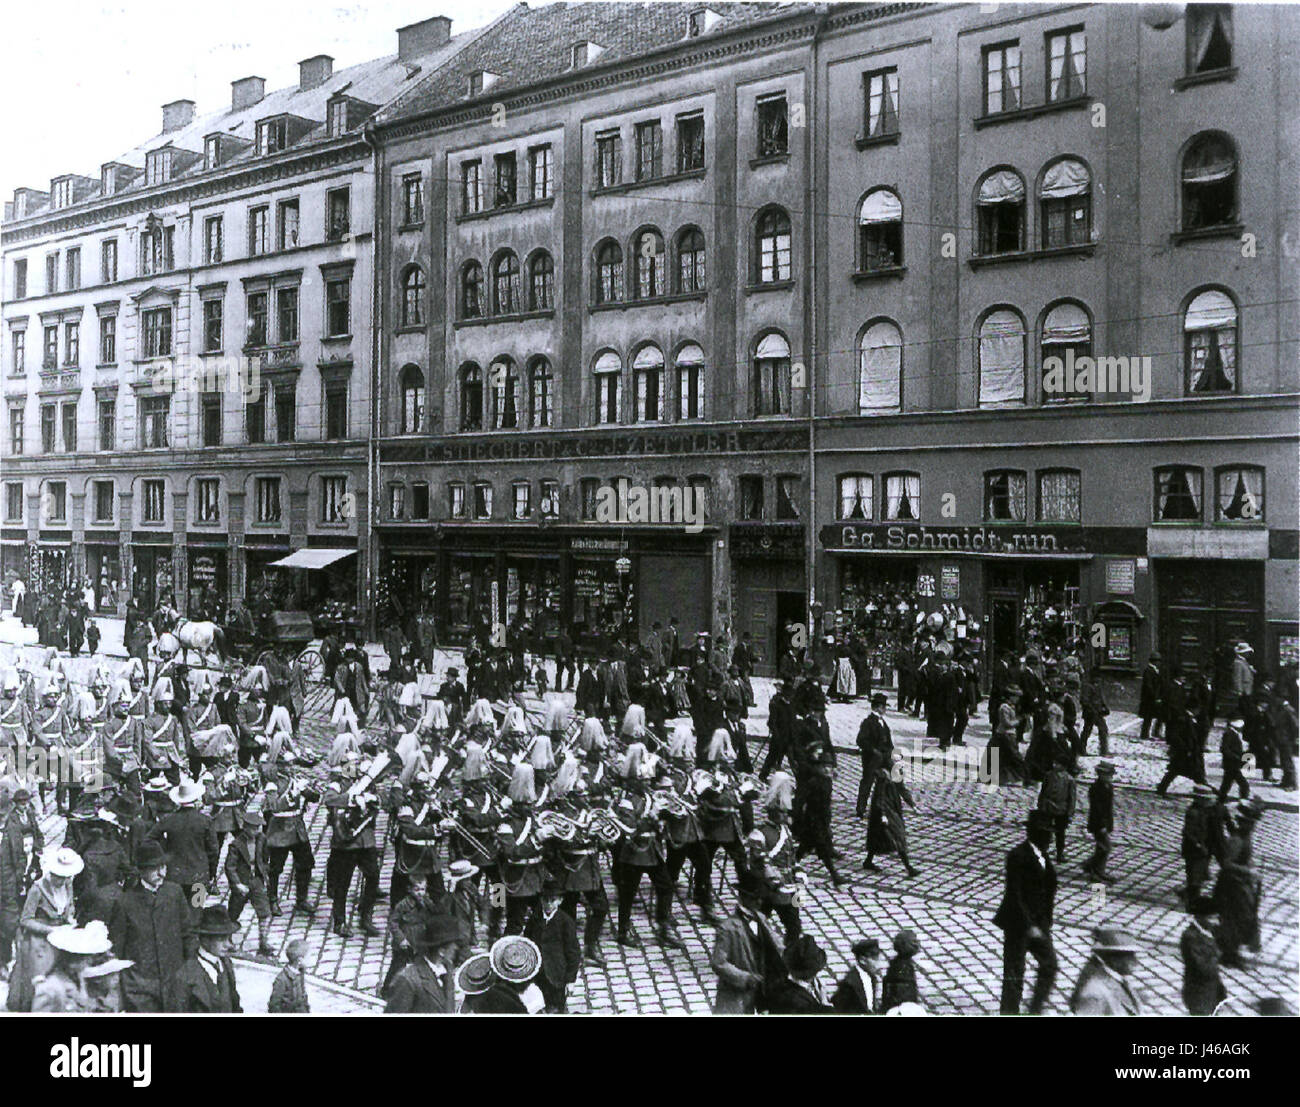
[376, 3, 816, 125]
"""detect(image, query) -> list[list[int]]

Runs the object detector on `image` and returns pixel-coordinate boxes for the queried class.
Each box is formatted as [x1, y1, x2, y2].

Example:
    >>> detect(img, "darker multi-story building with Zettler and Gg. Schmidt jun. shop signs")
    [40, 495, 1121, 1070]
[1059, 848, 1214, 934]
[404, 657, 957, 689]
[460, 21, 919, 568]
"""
[376, 4, 1297, 672]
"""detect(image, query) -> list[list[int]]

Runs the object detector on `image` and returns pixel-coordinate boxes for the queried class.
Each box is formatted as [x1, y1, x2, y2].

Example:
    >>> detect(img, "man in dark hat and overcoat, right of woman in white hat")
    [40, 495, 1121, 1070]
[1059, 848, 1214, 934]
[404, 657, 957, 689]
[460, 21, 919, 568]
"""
[108, 841, 196, 1012]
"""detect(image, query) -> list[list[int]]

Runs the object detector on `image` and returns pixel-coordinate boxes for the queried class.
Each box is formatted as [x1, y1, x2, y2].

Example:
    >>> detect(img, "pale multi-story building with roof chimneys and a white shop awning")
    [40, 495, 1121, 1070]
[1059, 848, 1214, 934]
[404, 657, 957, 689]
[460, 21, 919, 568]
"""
[0, 18, 488, 615]
